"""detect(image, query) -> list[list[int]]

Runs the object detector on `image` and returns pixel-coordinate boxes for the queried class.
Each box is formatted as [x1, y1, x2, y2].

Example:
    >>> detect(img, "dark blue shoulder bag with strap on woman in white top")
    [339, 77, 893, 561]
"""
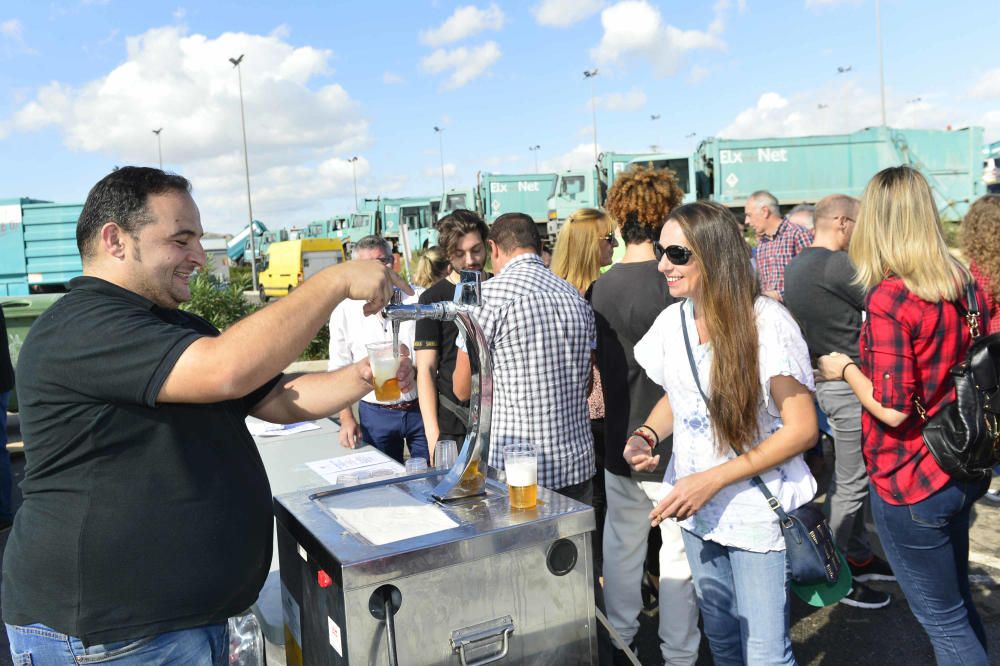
[681, 305, 841, 585]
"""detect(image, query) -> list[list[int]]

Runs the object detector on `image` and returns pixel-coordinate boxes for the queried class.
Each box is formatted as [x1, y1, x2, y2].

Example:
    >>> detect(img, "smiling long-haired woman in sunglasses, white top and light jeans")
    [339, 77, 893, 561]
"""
[624, 202, 817, 664]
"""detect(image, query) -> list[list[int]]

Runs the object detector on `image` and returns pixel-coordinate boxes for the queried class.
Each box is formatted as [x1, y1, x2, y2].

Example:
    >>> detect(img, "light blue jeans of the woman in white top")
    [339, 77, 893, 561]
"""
[681, 529, 796, 666]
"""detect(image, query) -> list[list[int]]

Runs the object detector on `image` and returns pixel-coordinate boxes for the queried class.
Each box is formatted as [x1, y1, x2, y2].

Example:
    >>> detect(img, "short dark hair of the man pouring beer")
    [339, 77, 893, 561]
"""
[76, 167, 191, 259]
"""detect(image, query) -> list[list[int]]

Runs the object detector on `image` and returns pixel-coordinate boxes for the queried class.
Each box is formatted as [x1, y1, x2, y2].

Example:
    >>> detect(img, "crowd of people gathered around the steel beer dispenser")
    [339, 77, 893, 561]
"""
[0, 162, 1000, 666]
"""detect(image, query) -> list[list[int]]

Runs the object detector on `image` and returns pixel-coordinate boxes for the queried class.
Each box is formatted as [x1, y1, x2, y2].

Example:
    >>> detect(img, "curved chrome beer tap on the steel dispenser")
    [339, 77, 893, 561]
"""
[382, 271, 493, 500]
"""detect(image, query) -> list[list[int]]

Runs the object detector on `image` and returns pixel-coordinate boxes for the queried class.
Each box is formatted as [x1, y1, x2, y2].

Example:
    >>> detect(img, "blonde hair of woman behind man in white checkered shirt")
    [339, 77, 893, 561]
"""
[549, 208, 615, 293]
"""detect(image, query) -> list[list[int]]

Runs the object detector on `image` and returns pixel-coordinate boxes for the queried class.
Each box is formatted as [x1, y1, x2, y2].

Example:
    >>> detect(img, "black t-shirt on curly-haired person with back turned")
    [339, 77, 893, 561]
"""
[590, 261, 675, 481]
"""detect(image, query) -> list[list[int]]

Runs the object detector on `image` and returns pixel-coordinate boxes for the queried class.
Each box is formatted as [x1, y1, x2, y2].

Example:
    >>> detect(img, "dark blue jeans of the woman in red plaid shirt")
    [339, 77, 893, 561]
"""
[870, 479, 989, 666]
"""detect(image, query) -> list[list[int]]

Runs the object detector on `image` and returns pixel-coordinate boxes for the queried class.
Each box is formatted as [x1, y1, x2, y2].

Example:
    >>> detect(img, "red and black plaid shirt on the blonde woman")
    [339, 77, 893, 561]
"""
[858, 277, 989, 504]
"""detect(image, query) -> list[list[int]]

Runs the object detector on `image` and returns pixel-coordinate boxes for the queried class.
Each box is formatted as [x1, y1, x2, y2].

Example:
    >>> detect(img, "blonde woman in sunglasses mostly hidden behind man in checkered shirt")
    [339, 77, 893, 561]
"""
[549, 208, 618, 575]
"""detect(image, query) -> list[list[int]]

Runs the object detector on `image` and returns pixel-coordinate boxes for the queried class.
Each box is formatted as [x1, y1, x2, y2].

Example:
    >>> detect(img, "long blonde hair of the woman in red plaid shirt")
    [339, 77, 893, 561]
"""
[849, 166, 969, 303]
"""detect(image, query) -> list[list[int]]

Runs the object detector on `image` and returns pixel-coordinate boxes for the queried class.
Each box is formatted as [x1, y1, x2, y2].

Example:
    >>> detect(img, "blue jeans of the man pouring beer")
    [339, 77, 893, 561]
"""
[7, 624, 229, 666]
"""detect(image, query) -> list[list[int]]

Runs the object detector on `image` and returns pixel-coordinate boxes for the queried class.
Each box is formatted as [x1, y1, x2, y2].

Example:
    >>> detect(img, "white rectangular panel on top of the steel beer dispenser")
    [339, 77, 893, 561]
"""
[323, 486, 458, 546]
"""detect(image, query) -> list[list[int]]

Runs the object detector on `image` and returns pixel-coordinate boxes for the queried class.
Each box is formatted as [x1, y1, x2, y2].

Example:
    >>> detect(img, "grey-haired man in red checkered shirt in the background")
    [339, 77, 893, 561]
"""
[744, 190, 812, 301]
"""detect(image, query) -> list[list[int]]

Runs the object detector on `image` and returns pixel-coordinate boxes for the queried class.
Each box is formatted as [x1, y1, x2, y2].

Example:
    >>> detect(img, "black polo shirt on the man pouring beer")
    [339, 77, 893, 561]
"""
[2, 277, 277, 644]
